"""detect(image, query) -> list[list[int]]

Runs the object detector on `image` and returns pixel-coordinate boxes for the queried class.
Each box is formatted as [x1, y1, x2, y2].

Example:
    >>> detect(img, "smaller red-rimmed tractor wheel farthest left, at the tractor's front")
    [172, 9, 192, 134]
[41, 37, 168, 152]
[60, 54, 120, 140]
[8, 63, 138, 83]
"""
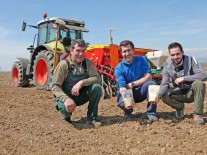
[11, 61, 29, 87]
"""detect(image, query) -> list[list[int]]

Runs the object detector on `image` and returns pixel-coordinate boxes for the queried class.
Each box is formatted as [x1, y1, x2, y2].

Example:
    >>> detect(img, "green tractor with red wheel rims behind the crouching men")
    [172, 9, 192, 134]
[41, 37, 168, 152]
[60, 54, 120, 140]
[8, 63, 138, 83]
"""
[11, 13, 88, 90]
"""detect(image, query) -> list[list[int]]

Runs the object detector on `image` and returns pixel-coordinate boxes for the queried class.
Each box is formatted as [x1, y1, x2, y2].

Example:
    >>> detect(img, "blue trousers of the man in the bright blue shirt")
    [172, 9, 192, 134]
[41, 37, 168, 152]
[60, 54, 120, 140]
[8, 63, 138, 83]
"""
[117, 81, 157, 115]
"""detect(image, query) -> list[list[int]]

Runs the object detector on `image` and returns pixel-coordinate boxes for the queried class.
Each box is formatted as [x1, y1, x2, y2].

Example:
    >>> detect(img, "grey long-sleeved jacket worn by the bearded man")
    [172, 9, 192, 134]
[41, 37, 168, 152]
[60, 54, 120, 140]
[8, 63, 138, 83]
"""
[159, 55, 207, 96]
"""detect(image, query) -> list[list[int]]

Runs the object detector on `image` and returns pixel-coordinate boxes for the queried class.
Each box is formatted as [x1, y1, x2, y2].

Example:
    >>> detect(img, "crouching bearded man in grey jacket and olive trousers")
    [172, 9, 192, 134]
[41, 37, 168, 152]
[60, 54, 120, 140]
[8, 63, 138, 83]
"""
[159, 42, 207, 124]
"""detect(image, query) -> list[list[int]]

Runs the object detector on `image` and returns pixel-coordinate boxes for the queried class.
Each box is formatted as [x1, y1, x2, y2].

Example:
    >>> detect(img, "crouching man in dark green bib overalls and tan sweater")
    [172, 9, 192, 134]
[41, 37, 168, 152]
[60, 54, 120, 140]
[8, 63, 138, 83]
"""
[52, 39, 102, 127]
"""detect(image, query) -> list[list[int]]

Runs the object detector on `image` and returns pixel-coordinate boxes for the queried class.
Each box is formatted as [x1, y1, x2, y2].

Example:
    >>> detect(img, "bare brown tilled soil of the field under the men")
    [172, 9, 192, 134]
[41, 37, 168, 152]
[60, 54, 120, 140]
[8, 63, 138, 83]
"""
[0, 72, 207, 155]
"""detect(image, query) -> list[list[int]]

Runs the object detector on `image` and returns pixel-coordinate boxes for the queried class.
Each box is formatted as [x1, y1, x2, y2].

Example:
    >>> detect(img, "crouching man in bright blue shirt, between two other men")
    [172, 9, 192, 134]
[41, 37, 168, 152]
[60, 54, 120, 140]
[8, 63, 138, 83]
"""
[115, 40, 158, 121]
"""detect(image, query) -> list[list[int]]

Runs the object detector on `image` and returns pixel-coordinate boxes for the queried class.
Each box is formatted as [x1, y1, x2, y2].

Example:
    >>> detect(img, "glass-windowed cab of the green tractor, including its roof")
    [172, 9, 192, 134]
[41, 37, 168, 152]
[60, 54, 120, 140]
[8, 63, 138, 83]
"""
[37, 18, 88, 46]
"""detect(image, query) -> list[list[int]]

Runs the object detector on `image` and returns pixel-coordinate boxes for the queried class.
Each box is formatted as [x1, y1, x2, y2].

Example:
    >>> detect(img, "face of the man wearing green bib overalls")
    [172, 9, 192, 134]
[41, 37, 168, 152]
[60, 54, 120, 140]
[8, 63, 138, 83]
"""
[70, 44, 86, 64]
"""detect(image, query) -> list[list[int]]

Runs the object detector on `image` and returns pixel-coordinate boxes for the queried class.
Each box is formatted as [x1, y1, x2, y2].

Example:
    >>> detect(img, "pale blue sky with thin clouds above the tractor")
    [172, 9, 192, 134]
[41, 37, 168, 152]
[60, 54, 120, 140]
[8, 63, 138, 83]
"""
[0, 0, 207, 71]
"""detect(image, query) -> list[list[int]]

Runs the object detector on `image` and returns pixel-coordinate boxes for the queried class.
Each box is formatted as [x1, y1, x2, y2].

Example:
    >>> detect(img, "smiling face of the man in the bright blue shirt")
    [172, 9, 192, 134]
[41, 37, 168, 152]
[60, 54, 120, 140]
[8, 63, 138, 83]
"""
[121, 45, 134, 63]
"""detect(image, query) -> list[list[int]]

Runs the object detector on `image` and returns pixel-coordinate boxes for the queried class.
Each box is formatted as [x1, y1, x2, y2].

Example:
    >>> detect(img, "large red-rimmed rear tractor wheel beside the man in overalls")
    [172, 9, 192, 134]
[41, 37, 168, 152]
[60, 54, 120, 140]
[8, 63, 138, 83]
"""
[33, 50, 53, 90]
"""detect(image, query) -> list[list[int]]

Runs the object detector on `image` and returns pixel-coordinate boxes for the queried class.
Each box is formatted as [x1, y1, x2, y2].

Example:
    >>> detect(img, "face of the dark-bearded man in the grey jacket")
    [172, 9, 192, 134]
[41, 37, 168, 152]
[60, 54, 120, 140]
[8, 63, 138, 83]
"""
[170, 47, 183, 66]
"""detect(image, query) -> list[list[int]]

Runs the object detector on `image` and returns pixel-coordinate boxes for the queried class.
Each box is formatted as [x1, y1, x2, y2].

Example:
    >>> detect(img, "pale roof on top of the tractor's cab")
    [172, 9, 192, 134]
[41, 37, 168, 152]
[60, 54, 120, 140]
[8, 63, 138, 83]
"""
[37, 17, 89, 32]
